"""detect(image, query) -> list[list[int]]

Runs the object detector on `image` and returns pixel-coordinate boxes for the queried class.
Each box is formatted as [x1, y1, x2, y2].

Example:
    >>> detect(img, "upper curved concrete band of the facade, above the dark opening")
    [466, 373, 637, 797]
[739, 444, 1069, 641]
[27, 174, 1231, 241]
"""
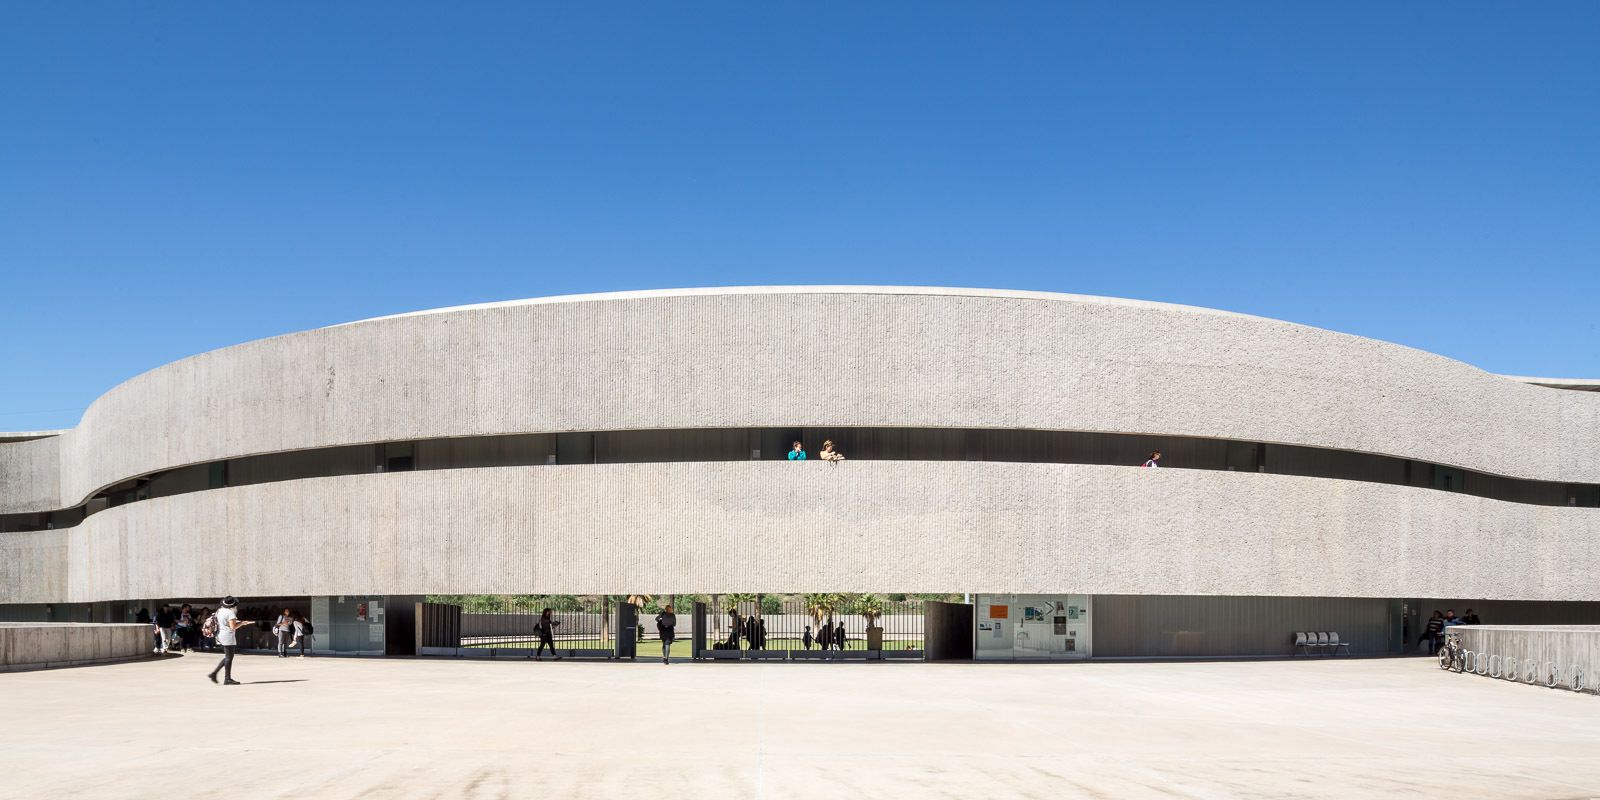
[0, 288, 1600, 514]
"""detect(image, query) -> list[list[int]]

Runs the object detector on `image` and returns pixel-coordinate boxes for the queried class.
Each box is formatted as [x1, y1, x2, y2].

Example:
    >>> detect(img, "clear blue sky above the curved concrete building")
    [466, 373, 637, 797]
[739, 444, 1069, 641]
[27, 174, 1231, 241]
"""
[0, 0, 1600, 430]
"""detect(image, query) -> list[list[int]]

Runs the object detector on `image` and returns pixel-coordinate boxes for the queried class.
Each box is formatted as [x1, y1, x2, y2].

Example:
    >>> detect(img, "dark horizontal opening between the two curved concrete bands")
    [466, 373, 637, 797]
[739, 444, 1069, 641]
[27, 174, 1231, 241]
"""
[0, 427, 1600, 533]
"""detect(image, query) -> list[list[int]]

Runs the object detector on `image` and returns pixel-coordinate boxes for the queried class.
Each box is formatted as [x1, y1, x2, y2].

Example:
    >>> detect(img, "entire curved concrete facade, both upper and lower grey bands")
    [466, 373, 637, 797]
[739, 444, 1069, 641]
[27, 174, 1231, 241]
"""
[0, 288, 1600, 603]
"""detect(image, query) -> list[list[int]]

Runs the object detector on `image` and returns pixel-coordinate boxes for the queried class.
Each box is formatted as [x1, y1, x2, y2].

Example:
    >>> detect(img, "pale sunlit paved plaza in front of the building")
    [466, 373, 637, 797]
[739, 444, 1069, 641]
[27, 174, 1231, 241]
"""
[0, 656, 1600, 800]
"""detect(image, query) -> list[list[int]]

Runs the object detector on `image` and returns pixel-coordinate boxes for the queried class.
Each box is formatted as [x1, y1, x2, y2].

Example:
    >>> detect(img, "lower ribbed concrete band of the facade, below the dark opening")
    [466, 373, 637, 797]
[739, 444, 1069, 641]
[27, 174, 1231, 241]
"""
[0, 461, 1600, 603]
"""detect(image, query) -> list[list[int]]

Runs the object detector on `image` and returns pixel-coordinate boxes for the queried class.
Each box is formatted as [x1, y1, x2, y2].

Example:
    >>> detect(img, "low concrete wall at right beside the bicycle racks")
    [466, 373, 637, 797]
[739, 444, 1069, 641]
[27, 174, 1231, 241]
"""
[1445, 626, 1600, 691]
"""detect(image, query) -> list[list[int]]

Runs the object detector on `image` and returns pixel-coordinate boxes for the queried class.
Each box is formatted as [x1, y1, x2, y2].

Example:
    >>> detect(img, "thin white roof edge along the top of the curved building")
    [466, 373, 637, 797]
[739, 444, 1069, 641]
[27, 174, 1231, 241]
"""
[330, 285, 1260, 328]
